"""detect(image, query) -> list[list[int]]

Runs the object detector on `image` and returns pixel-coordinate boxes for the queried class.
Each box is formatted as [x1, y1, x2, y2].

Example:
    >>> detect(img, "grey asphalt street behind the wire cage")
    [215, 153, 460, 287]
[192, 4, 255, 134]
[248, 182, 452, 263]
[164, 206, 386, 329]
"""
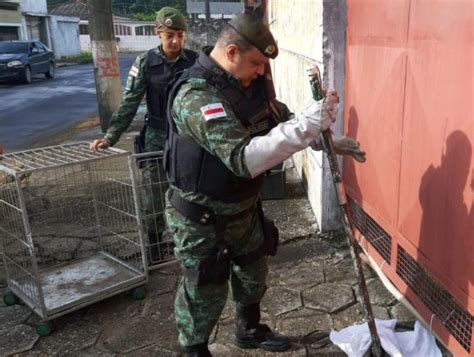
[0, 53, 137, 152]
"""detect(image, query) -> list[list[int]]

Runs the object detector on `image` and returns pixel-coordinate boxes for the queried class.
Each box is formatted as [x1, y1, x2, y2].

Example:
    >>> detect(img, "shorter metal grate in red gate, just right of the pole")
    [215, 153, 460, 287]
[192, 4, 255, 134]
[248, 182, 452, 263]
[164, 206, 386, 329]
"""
[348, 197, 392, 264]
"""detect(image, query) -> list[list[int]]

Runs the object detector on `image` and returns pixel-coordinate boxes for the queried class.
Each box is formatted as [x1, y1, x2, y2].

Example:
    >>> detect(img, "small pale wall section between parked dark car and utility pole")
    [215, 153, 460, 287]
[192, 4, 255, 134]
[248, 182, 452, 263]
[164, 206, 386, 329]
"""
[50, 15, 81, 58]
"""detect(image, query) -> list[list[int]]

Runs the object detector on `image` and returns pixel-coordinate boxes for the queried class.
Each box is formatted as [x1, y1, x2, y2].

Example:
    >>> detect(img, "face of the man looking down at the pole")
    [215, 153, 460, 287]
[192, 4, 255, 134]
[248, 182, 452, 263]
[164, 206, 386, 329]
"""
[231, 47, 268, 88]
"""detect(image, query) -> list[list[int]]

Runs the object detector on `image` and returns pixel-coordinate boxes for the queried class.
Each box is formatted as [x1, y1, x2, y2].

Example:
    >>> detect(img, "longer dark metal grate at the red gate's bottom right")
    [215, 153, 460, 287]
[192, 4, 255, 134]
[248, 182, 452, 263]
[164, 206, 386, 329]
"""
[397, 246, 473, 352]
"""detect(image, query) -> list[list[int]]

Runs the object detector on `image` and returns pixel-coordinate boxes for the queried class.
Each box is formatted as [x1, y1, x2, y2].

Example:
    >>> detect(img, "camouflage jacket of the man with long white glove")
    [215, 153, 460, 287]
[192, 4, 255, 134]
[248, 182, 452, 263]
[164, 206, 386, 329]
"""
[171, 74, 258, 215]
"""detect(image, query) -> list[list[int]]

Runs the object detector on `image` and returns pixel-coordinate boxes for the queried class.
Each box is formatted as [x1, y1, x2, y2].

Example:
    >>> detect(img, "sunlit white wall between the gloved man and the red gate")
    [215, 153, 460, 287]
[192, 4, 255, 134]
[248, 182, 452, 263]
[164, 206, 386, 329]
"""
[267, 0, 343, 231]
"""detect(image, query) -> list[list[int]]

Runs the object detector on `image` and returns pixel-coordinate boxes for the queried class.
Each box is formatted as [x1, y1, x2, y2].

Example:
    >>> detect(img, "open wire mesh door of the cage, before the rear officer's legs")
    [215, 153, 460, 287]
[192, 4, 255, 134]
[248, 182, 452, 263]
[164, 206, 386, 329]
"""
[129, 151, 174, 269]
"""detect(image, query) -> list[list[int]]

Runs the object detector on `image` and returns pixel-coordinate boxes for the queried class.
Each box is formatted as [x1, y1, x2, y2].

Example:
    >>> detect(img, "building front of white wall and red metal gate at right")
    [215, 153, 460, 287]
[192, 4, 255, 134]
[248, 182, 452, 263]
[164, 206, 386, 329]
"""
[266, 0, 474, 357]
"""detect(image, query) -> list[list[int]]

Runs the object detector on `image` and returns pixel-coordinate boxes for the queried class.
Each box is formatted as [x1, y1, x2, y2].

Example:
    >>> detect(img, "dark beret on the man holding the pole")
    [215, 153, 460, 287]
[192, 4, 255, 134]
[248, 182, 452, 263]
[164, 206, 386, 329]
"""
[229, 13, 278, 58]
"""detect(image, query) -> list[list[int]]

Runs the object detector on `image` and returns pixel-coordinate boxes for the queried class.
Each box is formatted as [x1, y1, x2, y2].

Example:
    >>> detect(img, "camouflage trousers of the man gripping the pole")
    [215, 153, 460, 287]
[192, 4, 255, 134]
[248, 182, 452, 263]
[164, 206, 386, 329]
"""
[165, 193, 268, 347]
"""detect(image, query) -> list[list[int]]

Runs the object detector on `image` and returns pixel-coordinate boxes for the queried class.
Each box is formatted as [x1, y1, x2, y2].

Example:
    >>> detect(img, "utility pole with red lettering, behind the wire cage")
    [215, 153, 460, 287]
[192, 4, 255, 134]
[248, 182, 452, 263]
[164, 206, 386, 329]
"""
[87, 0, 121, 133]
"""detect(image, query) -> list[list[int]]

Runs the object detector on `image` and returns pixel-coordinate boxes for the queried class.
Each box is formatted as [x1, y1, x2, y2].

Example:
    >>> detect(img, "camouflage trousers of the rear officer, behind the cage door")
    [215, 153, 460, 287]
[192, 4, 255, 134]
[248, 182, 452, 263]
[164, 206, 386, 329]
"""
[142, 126, 168, 237]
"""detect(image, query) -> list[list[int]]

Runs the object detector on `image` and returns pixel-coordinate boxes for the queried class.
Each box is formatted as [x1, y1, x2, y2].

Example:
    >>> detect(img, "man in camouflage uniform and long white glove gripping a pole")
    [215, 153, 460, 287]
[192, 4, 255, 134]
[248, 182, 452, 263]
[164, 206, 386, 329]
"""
[165, 14, 348, 356]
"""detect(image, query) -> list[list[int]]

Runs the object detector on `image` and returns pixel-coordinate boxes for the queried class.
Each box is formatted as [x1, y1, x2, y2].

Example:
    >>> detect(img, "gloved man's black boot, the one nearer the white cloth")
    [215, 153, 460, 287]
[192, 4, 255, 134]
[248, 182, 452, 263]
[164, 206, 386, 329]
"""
[234, 304, 291, 352]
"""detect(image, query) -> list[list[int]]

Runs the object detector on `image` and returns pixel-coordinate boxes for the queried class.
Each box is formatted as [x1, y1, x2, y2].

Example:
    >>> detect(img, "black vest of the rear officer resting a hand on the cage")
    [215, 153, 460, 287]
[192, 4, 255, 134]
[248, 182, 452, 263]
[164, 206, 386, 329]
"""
[146, 49, 197, 130]
